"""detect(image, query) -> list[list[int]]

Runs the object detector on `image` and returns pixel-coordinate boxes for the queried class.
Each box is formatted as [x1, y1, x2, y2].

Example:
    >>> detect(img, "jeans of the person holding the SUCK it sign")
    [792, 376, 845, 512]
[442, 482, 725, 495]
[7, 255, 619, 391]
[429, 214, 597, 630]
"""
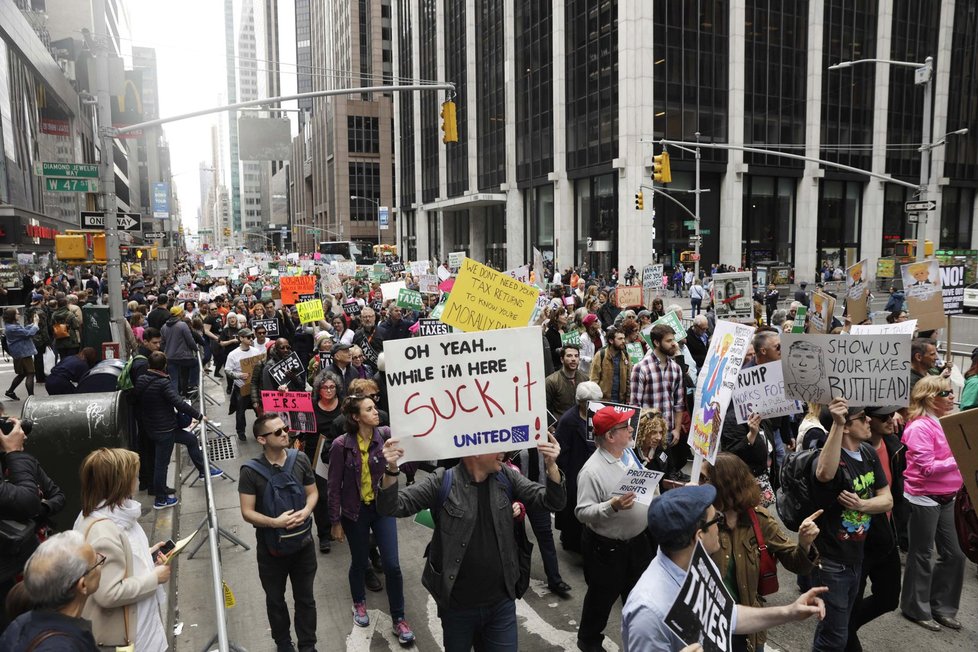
[438, 598, 518, 652]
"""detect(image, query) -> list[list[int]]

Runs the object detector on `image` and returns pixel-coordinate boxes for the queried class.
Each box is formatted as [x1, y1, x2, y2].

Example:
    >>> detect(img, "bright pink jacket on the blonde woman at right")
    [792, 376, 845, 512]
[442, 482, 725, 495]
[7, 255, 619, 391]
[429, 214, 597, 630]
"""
[903, 416, 963, 496]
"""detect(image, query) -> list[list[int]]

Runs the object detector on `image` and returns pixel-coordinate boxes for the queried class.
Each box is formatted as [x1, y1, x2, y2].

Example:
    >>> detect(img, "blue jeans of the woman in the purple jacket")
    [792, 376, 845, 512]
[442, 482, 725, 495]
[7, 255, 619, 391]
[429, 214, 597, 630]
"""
[342, 503, 404, 620]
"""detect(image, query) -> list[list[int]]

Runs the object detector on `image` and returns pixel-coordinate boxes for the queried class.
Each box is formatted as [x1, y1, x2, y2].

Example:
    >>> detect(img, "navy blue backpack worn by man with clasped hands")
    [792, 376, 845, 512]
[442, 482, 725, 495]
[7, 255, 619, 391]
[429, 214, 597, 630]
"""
[244, 448, 312, 557]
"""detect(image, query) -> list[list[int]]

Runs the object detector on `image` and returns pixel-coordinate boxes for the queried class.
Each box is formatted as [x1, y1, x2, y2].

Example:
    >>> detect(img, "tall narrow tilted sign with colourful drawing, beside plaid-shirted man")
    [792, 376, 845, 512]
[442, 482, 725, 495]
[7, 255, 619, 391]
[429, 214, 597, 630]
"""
[690, 321, 754, 464]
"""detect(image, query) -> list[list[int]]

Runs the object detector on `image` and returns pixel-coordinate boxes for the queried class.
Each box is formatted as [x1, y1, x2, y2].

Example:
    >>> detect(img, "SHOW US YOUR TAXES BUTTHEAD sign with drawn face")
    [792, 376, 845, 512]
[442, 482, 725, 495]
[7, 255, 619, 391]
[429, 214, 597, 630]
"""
[781, 333, 910, 407]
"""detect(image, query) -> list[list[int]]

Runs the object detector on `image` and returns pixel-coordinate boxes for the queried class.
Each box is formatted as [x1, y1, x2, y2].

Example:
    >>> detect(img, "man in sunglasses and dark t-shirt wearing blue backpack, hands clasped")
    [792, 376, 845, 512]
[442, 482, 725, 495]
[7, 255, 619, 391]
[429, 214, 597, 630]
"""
[238, 412, 319, 652]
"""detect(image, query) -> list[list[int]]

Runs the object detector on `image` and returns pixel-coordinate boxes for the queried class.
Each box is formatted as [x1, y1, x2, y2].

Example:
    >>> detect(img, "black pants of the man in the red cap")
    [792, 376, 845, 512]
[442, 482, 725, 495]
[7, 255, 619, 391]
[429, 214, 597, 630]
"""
[577, 528, 652, 646]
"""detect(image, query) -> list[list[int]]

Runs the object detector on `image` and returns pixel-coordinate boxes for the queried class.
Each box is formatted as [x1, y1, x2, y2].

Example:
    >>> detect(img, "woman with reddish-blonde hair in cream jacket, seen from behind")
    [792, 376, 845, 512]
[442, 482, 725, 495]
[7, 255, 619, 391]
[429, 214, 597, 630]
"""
[74, 448, 170, 652]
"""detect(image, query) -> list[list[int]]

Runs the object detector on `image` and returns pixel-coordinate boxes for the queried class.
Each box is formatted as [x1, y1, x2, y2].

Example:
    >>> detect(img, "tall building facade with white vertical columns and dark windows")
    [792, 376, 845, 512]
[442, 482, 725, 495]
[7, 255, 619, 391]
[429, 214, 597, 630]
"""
[392, 0, 978, 280]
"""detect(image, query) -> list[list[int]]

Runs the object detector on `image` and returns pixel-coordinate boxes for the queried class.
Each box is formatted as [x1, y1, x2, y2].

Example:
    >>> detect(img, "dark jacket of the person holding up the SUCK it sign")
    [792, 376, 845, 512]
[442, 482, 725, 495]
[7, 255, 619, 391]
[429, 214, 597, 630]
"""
[377, 464, 567, 608]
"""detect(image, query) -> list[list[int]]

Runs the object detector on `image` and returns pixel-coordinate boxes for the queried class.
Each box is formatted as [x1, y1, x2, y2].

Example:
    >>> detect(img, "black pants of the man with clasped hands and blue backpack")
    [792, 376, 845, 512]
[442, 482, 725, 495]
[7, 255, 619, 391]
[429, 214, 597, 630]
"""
[257, 538, 316, 652]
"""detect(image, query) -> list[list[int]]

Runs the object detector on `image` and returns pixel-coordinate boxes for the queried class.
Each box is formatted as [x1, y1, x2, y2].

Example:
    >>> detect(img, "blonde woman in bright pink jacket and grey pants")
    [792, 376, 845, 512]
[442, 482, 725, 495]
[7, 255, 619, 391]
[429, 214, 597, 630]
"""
[900, 376, 965, 632]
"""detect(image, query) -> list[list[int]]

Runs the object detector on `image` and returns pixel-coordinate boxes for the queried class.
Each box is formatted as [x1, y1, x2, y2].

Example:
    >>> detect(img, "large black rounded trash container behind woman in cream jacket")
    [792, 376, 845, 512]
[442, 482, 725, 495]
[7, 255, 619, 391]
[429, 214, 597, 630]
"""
[21, 392, 130, 531]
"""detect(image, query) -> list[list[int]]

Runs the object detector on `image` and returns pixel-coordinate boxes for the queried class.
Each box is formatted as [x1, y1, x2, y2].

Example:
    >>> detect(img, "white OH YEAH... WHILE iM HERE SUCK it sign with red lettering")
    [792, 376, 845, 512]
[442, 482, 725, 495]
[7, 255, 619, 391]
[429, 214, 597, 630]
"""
[384, 326, 547, 462]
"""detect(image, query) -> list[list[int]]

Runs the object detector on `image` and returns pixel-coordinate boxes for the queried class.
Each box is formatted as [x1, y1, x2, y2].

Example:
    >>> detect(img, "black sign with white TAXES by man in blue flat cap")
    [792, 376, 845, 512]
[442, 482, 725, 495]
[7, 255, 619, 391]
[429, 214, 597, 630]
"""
[666, 542, 734, 652]
